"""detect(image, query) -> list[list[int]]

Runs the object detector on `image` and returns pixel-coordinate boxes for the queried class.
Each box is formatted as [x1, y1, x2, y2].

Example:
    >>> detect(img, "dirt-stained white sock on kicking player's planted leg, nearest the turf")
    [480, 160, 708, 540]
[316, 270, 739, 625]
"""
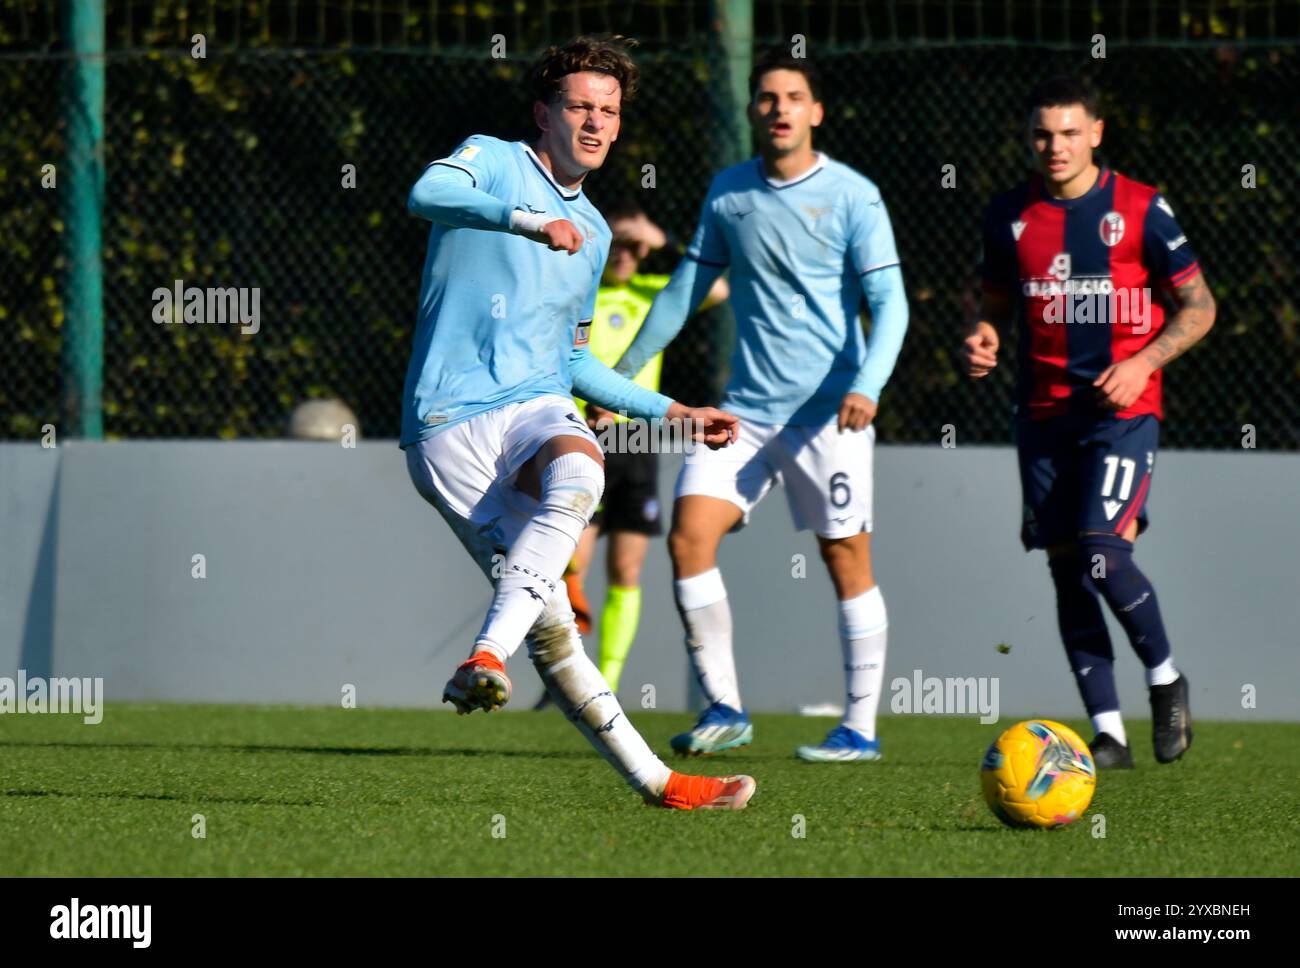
[528, 608, 672, 800]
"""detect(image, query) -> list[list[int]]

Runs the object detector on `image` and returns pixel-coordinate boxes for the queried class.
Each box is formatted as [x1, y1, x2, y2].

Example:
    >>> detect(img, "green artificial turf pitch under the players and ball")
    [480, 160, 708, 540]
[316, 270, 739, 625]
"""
[0, 704, 1300, 876]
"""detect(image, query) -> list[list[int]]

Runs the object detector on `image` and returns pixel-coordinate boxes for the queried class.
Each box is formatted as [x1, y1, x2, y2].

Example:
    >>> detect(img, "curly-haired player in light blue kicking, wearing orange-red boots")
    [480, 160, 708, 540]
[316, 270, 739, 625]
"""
[402, 38, 754, 809]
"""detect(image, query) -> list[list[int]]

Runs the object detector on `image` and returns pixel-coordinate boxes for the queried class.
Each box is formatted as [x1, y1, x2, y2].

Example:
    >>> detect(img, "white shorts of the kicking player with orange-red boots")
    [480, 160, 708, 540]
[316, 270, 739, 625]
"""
[406, 396, 599, 581]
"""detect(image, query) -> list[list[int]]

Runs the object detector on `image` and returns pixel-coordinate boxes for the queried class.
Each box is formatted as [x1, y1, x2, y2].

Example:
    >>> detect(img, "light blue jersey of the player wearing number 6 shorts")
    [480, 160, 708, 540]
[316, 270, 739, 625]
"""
[616, 155, 907, 425]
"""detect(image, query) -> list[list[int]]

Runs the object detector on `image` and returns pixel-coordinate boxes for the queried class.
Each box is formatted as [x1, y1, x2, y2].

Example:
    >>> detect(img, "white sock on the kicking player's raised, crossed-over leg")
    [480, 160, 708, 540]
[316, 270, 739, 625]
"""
[475, 453, 605, 661]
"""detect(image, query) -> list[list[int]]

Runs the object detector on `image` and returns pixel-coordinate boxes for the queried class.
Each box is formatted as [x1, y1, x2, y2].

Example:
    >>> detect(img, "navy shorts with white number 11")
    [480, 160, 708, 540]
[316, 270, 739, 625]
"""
[1015, 413, 1160, 551]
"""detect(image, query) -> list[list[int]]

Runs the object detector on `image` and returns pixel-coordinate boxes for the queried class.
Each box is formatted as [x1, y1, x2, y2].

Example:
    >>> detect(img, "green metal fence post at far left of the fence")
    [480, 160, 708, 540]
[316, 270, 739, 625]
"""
[61, 0, 104, 440]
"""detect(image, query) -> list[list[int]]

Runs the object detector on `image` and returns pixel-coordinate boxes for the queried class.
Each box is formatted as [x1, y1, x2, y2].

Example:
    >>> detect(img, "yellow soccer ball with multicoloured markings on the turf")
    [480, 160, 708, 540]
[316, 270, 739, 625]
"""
[980, 720, 1097, 828]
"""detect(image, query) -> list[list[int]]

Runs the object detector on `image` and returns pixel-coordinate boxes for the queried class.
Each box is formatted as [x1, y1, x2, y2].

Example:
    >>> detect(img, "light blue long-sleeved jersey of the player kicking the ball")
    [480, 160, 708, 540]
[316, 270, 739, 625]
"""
[402, 135, 671, 447]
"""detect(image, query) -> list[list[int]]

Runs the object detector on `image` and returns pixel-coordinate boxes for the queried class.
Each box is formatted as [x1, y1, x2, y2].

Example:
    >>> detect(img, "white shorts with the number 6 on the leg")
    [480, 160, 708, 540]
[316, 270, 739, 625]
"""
[675, 420, 876, 538]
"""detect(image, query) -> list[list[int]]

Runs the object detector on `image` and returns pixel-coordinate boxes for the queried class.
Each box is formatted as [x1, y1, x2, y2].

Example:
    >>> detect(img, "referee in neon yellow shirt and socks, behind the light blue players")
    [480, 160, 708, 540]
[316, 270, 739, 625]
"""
[538, 205, 729, 708]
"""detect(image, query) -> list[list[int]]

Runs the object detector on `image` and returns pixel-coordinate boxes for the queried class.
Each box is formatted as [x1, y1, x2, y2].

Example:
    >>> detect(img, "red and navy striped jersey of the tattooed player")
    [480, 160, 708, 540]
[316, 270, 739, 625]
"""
[983, 168, 1200, 420]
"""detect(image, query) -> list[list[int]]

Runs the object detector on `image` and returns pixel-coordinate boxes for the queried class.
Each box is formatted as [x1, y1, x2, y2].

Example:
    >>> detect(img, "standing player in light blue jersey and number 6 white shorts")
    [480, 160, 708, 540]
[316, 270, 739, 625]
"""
[615, 56, 907, 763]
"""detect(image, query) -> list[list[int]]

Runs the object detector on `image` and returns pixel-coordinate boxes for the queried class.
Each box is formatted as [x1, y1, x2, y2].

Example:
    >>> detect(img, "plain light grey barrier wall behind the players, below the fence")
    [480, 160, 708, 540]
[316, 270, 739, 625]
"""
[0, 442, 1300, 720]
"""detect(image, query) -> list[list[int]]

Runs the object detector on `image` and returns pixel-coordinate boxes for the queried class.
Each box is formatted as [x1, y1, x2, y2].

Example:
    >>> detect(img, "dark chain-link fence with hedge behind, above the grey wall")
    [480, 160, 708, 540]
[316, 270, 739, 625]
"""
[0, 3, 1300, 448]
